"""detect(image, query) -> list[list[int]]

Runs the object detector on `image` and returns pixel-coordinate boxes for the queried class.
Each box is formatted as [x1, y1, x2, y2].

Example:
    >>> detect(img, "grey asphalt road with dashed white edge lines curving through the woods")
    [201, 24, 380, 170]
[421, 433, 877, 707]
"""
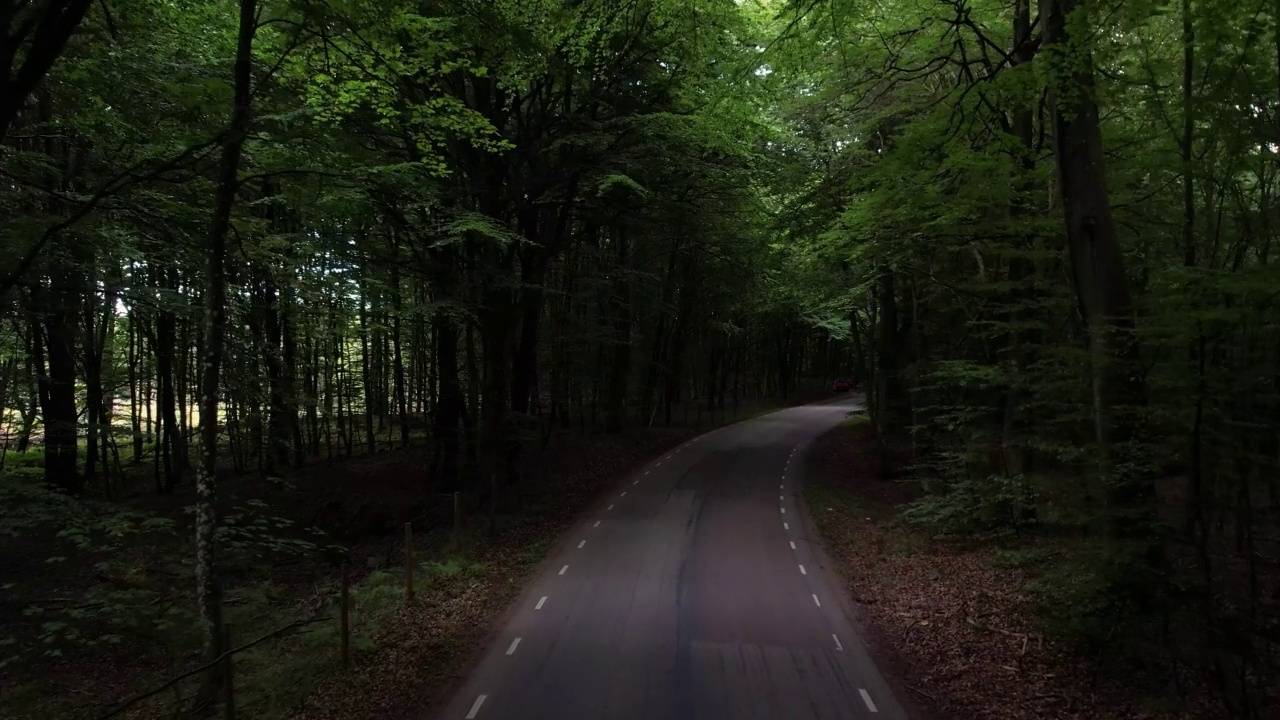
[442, 397, 906, 720]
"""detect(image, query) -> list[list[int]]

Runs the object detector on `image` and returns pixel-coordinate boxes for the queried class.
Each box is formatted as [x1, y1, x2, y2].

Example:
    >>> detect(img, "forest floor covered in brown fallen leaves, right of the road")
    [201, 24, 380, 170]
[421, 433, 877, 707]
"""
[805, 416, 1221, 720]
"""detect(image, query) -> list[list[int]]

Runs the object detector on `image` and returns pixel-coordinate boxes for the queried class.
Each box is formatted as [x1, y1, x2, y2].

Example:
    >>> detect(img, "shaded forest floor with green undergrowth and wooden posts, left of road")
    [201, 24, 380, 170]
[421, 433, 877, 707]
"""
[0, 392, 819, 720]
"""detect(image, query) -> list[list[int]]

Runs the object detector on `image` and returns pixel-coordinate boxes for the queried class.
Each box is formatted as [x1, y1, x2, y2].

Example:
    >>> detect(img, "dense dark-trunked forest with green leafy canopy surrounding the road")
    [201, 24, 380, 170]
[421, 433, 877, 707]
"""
[0, 0, 1280, 719]
